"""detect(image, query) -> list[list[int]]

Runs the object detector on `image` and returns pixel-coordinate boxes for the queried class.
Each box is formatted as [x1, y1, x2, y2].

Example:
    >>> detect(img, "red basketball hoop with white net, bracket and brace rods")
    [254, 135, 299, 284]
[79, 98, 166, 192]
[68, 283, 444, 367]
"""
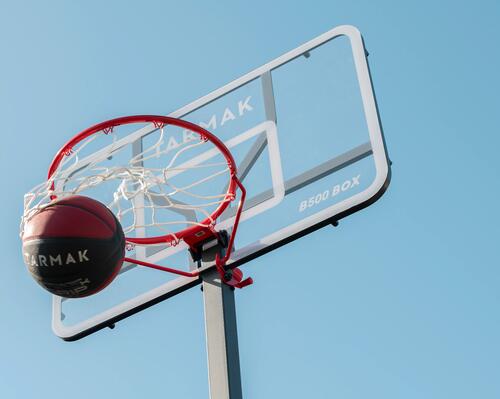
[21, 115, 252, 288]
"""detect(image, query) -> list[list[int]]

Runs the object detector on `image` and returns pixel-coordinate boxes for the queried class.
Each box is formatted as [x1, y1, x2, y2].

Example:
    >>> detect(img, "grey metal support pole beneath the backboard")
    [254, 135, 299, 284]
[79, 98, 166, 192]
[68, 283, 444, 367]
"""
[201, 245, 243, 399]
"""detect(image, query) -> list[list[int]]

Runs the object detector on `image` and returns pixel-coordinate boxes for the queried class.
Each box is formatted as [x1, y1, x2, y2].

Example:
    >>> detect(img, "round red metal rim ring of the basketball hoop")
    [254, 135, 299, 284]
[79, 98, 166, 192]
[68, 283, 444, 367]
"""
[47, 115, 240, 245]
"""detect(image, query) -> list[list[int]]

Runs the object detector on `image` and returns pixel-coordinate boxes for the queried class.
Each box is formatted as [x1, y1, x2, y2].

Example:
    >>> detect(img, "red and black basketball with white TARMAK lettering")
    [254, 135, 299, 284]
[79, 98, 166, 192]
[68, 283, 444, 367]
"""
[22, 195, 125, 298]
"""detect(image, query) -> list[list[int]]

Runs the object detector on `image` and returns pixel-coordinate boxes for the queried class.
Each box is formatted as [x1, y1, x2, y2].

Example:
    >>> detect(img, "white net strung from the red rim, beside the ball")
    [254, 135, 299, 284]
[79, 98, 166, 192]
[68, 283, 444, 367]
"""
[21, 119, 234, 244]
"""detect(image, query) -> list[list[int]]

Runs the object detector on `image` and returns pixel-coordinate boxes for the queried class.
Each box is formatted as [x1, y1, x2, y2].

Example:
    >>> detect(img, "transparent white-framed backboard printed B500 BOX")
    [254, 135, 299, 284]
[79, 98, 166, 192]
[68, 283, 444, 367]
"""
[52, 26, 390, 340]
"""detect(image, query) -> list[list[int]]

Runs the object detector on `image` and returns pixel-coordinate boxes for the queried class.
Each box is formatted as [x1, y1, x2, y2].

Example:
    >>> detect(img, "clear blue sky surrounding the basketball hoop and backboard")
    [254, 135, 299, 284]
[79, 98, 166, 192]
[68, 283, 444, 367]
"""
[0, 0, 500, 399]
